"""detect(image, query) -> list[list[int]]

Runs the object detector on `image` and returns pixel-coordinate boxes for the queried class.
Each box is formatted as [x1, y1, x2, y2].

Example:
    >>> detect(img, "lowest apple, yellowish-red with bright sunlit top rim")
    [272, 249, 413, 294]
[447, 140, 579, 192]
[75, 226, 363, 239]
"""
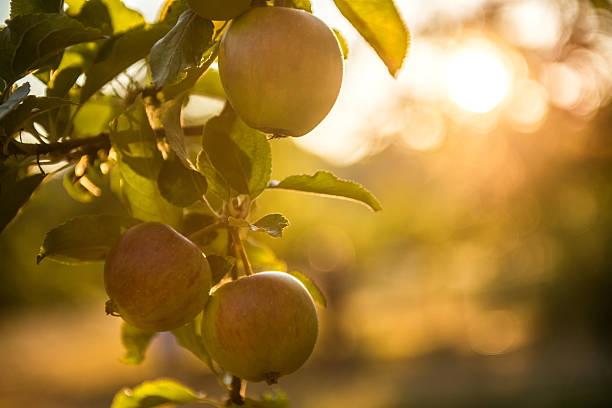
[202, 272, 319, 384]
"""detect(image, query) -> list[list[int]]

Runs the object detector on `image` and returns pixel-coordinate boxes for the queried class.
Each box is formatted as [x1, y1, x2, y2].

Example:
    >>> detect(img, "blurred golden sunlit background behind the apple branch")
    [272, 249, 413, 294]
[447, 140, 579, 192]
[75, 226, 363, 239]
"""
[0, 0, 612, 408]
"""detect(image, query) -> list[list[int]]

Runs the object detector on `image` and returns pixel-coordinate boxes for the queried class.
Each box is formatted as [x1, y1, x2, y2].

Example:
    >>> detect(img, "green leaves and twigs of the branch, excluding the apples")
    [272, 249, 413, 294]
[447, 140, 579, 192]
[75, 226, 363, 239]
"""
[0, 0, 409, 408]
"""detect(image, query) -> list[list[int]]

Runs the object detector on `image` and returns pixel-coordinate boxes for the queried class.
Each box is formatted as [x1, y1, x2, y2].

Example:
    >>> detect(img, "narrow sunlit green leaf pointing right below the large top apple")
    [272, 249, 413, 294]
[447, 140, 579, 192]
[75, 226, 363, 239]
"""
[270, 171, 382, 211]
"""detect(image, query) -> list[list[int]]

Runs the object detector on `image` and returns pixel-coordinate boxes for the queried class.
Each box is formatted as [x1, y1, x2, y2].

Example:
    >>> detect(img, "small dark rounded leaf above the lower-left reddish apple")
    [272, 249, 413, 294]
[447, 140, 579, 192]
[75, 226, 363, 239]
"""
[157, 156, 206, 207]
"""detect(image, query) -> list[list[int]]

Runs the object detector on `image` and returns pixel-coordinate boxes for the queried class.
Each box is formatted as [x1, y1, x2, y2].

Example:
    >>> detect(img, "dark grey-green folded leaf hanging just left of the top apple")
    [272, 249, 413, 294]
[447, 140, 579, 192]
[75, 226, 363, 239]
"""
[149, 10, 214, 86]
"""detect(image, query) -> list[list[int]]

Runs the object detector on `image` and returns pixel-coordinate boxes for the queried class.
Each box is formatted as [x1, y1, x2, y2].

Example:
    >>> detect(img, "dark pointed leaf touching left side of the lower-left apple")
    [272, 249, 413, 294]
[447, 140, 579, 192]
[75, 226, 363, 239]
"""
[36, 215, 138, 264]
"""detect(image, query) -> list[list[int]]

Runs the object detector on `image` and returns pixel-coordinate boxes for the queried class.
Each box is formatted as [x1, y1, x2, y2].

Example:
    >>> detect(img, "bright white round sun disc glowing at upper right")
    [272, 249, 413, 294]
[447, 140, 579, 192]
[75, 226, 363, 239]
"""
[447, 44, 510, 113]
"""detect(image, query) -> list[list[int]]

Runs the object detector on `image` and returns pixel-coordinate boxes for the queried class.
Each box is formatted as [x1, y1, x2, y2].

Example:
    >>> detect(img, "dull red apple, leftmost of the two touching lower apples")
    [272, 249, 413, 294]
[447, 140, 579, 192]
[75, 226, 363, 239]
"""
[104, 222, 212, 331]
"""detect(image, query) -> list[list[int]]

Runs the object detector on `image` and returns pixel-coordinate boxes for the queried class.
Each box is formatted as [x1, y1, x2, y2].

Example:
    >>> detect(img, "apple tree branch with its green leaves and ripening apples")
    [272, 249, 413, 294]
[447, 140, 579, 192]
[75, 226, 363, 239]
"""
[0, 0, 409, 408]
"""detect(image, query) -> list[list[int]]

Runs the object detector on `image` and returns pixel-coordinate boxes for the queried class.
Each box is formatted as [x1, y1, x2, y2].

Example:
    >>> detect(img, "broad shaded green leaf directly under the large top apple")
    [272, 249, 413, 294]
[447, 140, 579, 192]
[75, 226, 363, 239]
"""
[203, 104, 272, 198]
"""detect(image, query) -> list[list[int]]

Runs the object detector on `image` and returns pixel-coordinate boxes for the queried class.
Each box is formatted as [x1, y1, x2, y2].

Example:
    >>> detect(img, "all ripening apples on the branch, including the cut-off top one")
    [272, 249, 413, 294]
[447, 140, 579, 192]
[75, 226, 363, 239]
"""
[104, 0, 343, 383]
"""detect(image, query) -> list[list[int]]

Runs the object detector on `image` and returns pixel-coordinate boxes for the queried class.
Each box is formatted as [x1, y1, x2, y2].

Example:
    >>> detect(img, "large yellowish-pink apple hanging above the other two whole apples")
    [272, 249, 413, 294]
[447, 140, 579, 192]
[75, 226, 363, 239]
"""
[219, 7, 344, 136]
